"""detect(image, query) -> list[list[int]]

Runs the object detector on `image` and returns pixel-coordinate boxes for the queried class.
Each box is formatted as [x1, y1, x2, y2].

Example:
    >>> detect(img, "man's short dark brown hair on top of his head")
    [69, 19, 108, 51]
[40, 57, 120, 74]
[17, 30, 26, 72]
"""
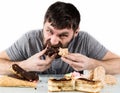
[44, 1, 80, 31]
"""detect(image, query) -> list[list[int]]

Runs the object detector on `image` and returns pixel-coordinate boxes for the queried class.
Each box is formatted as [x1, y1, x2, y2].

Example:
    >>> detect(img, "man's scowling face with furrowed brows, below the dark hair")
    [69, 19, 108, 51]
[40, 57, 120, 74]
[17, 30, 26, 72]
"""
[43, 22, 75, 47]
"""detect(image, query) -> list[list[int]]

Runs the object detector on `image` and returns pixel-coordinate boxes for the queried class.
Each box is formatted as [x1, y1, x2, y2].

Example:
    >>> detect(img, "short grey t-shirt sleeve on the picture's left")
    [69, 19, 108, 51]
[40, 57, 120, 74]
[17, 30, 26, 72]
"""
[6, 35, 28, 61]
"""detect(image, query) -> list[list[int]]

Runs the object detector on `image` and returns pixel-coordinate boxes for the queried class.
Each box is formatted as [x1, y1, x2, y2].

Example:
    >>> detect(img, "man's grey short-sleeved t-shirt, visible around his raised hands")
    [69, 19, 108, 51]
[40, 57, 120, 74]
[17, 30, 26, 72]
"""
[6, 30, 108, 74]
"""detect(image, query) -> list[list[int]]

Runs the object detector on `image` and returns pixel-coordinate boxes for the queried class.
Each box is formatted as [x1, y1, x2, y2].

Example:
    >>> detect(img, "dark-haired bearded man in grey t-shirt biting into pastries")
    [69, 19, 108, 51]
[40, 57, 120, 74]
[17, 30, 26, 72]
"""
[0, 2, 120, 74]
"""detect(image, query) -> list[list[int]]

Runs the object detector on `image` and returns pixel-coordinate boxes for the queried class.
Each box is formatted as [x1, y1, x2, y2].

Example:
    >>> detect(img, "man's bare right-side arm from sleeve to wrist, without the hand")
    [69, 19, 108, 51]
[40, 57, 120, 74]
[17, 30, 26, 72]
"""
[91, 51, 120, 74]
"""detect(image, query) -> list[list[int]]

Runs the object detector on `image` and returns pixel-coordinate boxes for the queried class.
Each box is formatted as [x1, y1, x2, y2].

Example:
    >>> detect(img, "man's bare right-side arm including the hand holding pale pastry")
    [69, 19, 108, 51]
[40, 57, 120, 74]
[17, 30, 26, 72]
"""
[62, 51, 120, 74]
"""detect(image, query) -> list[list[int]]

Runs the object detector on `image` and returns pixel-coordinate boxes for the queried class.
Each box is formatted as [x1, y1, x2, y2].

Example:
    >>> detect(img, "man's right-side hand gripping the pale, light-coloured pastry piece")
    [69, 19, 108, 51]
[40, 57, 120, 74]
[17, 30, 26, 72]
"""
[61, 53, 94, 71]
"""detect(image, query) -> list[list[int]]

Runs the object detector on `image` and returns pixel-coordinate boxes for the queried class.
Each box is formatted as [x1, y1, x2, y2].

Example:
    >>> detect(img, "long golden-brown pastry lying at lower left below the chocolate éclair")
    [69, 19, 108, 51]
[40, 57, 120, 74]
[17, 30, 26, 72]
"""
[0, 76, 37, 88]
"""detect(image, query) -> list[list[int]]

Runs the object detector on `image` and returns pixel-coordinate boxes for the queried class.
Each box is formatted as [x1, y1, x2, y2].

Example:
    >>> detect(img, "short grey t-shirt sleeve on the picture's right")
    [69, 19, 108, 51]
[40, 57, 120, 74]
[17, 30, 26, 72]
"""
[86, 34, 108, 60]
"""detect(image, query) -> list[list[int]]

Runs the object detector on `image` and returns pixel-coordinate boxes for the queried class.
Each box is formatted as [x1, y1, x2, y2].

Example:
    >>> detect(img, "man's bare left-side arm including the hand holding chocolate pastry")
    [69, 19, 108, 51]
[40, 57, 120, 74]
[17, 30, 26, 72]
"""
[0, 49, 55, 75]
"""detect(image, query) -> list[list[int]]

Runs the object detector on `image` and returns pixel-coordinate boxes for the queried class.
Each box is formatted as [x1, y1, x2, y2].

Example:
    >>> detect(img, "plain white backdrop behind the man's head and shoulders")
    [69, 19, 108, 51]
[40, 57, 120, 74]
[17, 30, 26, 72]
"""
[0, 0, 120, 55]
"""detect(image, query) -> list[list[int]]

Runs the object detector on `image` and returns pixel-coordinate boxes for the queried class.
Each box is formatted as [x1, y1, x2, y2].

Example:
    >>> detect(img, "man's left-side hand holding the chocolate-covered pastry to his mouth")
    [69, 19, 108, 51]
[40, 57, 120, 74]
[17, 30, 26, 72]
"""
[19, 49, 55, 72]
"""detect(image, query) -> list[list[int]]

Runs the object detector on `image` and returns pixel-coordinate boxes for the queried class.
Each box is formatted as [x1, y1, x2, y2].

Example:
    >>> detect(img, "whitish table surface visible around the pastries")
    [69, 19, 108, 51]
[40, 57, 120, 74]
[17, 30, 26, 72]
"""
[0, 75, 120, 93]
